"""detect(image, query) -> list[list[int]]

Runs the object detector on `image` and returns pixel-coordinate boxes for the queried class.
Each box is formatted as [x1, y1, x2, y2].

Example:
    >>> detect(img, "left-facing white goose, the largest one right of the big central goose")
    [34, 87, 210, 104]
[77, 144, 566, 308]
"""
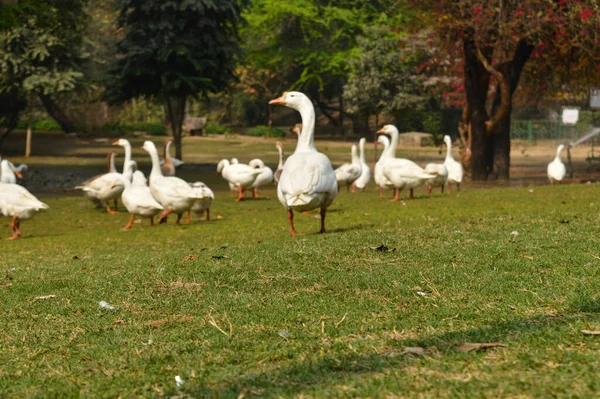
[377, 125, 434, 201]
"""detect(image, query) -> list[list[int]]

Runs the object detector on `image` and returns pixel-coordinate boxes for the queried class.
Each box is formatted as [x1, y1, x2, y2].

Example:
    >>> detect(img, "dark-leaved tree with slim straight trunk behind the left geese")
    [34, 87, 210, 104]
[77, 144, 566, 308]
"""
[105, 0, 246, 159]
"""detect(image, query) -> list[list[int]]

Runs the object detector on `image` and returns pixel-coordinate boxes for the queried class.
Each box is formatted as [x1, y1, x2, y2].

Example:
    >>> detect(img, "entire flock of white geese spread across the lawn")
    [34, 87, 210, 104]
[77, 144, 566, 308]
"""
[0, 91, 565, 239]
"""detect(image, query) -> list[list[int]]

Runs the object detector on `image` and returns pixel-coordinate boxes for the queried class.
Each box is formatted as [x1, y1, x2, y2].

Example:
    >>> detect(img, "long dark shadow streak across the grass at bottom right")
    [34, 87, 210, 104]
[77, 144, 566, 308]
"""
[190, 314, 596, 398]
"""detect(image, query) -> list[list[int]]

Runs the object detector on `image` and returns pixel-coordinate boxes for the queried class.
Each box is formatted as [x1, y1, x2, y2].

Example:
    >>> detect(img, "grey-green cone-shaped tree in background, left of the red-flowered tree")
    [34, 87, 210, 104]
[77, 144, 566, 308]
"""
[344, 25, 425, 119]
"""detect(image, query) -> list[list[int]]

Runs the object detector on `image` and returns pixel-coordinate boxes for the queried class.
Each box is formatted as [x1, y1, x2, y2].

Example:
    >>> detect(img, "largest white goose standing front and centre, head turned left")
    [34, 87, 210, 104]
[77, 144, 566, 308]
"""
[269, 91, 338, 236]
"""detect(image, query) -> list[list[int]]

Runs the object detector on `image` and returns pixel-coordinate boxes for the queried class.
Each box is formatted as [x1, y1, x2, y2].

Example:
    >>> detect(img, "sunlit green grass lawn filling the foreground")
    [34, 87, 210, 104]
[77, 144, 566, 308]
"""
[0, 185, 600, 398]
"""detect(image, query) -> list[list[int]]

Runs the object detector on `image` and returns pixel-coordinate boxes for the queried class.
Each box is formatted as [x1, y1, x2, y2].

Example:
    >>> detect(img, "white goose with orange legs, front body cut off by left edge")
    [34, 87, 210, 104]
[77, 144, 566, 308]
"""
[0, 183, 48, 240]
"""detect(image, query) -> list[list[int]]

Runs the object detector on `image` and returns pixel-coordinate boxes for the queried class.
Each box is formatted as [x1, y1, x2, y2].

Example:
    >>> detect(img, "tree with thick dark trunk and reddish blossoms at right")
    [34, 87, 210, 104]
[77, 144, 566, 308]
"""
[418, 0, 600, 180]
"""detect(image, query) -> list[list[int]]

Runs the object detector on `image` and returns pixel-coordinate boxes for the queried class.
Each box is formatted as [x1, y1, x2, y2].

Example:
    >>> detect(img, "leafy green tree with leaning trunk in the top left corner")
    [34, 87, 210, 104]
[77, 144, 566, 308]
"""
[0, 0, 87, 133]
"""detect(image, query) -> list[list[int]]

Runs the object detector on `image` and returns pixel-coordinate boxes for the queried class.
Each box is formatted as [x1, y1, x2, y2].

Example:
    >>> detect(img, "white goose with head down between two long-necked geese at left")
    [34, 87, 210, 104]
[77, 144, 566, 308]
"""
[121, 169, 164, 230]
